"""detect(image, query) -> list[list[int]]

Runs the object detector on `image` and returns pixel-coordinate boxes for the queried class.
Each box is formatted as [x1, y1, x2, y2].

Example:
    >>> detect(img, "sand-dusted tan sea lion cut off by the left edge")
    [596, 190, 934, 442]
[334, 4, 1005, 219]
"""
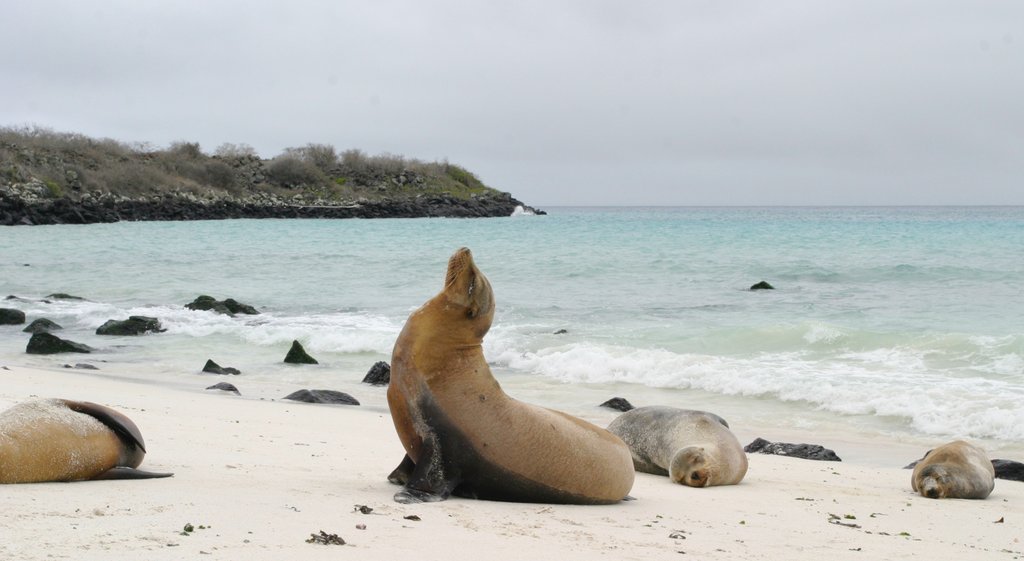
[0, 399, 171, 483]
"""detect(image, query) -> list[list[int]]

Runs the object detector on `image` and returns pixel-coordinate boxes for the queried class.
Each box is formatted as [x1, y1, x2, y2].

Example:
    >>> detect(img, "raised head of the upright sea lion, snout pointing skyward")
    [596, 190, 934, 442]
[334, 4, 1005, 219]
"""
[441, 248, 495, 339]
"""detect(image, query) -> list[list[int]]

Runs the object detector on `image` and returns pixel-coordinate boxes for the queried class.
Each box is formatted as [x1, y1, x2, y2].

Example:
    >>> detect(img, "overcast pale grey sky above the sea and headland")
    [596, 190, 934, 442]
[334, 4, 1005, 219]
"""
[0, 0, 1024, 208]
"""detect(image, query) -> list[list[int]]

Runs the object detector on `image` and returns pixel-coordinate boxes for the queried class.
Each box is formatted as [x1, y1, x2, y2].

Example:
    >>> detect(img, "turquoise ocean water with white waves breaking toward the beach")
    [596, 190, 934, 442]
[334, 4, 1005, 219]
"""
[0, 207, 1024, 460]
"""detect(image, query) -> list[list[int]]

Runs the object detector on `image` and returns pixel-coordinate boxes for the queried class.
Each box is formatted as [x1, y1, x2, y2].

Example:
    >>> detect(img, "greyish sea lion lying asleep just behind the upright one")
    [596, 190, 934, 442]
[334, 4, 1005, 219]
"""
[608, 405, 746, 487]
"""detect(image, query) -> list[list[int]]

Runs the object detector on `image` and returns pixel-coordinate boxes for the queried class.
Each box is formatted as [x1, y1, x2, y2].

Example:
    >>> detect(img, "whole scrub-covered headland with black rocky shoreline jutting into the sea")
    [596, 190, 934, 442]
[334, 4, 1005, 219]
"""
[0, 128, 543, 225]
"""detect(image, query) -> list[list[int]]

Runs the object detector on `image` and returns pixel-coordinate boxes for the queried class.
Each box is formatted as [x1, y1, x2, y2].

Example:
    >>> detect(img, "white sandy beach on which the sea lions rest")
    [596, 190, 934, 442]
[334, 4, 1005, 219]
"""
[0, 363, 1024, 561]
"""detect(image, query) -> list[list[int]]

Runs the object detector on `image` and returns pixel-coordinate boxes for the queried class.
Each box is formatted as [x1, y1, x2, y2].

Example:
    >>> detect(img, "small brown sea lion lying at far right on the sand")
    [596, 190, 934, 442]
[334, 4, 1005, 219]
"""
[910, 440, 995, 499]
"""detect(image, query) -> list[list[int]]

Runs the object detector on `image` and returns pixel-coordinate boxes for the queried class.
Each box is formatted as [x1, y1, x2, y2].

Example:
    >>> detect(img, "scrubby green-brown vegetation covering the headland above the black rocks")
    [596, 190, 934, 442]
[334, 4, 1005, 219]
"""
[0, 127, 503, 204]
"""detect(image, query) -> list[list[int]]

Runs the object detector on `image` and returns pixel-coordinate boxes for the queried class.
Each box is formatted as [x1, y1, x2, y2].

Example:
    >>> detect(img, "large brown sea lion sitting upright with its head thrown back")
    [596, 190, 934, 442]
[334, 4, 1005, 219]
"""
[387, 248, 634, 505]
